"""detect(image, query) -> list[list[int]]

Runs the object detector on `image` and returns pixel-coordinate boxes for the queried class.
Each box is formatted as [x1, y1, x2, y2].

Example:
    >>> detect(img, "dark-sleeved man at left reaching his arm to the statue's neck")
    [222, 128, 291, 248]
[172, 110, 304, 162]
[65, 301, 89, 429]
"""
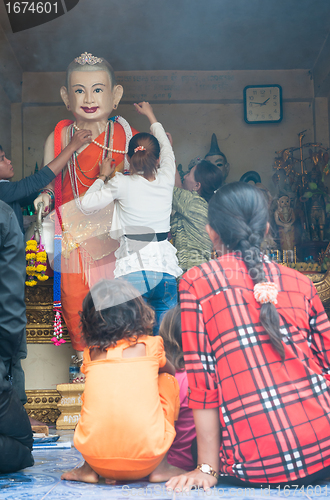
[0, 129, 92, 232]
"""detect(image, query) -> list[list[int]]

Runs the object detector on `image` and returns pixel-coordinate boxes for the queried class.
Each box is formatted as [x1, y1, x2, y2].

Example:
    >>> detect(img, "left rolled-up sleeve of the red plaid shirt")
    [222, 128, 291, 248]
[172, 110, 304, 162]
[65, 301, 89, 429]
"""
[180, 278, 220, 409]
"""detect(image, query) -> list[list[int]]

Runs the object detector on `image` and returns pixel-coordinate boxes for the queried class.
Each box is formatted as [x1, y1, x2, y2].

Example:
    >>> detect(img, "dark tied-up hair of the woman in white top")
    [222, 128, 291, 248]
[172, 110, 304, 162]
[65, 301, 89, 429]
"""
[127, 132, 160, 179]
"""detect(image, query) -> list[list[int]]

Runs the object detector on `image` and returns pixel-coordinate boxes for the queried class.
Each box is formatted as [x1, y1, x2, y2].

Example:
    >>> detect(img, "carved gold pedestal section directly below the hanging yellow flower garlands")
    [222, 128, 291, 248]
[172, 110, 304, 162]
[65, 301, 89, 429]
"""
[25, 279, 70, 344]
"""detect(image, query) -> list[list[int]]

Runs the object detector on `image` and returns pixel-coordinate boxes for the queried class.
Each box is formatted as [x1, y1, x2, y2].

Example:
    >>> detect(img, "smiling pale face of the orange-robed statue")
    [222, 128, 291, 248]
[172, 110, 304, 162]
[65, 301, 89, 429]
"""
[68, 71, 114, 122]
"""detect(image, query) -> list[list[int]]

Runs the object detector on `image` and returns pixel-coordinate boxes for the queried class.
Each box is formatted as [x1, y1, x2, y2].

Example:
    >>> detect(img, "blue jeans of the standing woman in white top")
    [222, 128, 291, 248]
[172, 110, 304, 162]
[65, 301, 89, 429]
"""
[121, 271, 178, 335]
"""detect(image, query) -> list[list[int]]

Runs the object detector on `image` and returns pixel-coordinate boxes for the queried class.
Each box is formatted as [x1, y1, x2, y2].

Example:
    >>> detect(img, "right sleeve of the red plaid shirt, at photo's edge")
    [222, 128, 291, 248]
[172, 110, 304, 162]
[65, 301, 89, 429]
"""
[308, 286, 330, 382]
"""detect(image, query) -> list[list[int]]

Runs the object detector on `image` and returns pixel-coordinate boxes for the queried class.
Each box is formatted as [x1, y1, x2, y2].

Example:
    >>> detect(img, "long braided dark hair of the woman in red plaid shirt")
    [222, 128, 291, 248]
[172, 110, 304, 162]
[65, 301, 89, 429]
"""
[209, 182, 285, 361]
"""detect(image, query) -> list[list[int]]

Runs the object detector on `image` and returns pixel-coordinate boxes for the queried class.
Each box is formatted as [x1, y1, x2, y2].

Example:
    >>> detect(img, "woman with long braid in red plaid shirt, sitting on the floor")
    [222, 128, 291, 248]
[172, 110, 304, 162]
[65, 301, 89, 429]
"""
[167, 182, 330, 488]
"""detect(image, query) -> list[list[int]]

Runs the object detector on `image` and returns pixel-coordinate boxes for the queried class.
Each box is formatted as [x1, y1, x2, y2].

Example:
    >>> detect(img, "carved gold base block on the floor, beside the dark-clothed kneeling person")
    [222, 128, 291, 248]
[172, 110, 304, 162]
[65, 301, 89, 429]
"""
[25, 389, 61, 424]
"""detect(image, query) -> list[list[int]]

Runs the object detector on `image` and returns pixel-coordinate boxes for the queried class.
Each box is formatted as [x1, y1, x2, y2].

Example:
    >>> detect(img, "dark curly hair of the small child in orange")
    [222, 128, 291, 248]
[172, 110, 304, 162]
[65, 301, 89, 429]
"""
[80, 279, 155, 349]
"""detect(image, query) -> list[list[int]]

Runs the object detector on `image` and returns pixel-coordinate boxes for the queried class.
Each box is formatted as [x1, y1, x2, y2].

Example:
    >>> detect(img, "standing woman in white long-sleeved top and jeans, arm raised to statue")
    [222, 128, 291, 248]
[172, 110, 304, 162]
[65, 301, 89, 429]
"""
[82, 102, 182, 334]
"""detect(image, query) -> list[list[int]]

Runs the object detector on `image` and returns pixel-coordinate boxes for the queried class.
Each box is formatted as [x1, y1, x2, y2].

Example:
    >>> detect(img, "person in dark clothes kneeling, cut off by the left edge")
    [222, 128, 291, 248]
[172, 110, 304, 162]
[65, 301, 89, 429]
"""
[0, 201, 33, 474]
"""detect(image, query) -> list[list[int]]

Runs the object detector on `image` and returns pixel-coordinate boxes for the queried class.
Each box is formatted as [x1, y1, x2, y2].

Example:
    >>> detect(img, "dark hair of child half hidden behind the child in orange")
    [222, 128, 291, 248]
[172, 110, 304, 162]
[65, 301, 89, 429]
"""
[159, 305, 185, 371]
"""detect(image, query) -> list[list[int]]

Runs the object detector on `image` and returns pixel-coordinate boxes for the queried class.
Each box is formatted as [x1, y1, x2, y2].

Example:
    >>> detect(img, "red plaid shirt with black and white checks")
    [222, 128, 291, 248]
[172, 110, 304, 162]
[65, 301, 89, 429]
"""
[180, 253, 330, 483]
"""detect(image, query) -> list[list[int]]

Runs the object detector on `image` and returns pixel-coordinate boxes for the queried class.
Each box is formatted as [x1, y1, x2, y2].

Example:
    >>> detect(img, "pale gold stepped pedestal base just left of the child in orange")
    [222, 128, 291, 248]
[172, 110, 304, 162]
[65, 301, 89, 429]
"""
[56, 384, 85, 429]
